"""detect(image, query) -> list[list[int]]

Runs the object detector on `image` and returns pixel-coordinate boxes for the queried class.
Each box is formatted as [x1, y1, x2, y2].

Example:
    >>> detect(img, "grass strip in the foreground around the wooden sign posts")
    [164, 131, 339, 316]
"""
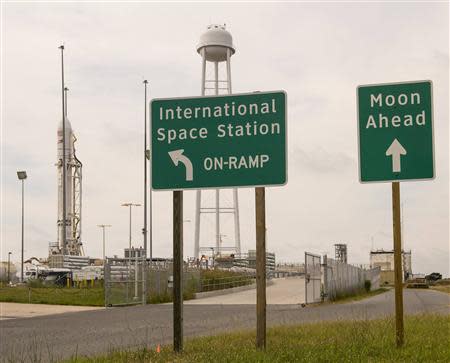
[66, 315, 450, 363]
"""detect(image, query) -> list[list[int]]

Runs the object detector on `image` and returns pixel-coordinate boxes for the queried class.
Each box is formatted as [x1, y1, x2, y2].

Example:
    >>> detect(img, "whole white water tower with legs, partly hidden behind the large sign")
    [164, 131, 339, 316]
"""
[194, 24, 241, 258]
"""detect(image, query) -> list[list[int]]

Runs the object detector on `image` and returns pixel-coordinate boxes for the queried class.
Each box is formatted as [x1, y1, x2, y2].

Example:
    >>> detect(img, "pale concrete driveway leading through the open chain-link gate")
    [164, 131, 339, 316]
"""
[186, 277, 305, 305]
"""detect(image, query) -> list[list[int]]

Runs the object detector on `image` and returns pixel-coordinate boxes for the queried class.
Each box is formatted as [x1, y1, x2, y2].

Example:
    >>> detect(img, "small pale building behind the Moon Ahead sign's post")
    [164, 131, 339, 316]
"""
[370, 250, 412, 285]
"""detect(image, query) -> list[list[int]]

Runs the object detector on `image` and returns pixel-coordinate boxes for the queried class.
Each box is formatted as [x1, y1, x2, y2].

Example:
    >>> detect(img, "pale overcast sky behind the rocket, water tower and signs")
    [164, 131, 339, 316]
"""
[1, 2, 449, 275]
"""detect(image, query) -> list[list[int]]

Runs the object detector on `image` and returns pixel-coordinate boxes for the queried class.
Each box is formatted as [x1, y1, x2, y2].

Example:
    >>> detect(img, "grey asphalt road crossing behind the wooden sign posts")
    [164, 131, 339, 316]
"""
[0, 290, 450, 362]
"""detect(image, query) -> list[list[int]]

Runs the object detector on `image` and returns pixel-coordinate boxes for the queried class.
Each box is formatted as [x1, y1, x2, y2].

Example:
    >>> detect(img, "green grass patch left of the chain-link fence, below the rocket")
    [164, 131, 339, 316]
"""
[0, 286, 105, 306]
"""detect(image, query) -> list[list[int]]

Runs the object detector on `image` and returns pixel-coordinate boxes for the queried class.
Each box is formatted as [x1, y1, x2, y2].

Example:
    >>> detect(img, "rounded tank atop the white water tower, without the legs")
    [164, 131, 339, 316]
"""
[197, 24, 235, 62]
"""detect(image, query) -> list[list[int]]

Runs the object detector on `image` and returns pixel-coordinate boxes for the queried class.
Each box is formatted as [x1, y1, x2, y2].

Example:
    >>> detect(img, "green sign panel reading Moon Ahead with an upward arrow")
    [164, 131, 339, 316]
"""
[357, 81, 434, 183]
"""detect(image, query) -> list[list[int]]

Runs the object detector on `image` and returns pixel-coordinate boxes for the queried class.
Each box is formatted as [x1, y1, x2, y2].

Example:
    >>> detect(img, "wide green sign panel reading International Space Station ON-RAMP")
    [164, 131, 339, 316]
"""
[150, 91, 287, 190]
